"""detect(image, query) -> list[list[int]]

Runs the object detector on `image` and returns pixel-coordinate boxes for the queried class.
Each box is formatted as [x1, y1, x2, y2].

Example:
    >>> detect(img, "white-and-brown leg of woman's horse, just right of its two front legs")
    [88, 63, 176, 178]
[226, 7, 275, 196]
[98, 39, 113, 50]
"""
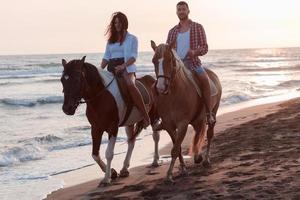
[120, 125, 135, 177]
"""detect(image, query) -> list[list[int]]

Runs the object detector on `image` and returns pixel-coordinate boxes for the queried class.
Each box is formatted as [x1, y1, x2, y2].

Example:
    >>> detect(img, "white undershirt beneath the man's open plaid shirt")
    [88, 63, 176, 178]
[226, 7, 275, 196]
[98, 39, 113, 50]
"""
[176, 29, 190, 59]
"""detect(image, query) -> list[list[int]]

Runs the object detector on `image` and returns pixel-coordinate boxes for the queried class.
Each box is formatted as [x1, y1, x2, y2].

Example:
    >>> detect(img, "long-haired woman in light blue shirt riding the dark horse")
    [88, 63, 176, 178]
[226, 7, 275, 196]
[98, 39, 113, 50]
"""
[101, 12, 150, 127]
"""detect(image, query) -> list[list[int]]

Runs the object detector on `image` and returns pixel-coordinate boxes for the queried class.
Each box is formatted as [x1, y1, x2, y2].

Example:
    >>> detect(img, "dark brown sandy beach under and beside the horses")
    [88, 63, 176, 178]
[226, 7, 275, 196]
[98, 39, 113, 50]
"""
[47, 98, 300, 199]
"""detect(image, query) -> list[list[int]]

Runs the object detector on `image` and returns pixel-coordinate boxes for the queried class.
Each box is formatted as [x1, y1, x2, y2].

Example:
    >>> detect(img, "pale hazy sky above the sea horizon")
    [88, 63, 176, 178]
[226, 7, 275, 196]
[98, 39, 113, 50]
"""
[0, 0, 300, 55]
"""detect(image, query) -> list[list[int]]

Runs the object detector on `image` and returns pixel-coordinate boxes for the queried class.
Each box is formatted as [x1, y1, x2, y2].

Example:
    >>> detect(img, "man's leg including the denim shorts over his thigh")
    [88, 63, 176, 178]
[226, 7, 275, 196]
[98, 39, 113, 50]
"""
[194, 66, 216, 126]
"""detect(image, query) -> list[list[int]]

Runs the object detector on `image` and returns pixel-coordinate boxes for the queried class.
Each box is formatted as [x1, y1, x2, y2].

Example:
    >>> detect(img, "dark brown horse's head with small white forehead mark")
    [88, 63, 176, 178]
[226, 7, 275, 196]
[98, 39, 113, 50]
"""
[60, 56, 85, 115]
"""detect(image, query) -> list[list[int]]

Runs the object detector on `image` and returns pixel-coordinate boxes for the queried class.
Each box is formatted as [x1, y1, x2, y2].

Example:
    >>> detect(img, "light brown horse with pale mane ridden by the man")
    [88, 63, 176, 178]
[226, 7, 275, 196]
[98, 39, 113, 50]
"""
[151, 41, 222, 182]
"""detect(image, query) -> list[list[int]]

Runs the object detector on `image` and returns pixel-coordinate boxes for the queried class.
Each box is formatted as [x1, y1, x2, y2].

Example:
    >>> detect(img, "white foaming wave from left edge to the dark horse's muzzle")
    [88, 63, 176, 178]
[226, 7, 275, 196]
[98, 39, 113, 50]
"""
[0, 96, 64, 107]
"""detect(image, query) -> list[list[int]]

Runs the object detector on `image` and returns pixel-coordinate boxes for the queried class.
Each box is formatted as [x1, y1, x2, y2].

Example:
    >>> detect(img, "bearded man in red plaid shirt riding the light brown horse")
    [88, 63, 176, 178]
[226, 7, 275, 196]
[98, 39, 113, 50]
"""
[167, 1, 215, 126]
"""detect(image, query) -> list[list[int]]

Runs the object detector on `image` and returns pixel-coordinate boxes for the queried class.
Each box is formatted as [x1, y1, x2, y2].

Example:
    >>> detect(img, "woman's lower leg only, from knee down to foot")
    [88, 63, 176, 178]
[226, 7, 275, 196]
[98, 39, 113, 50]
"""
[128, 84, 150, 128]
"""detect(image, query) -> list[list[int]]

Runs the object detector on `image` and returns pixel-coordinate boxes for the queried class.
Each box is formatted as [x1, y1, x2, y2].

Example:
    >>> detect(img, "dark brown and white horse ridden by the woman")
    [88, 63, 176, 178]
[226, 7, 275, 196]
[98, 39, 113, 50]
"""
[61, 56, 159, 185]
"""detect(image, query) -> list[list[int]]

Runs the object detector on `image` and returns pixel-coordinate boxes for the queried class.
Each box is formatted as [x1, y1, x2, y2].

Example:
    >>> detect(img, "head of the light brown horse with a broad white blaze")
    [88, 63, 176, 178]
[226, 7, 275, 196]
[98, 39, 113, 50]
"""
[151, 40, 176, 94]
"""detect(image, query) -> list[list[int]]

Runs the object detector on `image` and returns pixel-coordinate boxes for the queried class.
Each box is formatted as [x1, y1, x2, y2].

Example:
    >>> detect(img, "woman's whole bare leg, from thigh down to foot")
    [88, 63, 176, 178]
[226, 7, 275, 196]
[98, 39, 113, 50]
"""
[123, 70, 150, 128]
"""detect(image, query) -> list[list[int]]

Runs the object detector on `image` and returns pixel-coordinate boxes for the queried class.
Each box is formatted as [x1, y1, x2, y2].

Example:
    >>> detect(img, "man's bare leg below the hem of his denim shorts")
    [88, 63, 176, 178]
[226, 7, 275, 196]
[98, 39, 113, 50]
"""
[197, 74, 216, 127]
